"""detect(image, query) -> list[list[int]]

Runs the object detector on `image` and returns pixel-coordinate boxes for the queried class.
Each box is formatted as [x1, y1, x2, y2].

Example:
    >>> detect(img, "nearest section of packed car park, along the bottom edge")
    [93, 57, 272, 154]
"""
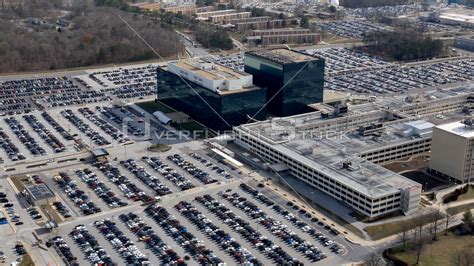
[51, 179, 346, 265]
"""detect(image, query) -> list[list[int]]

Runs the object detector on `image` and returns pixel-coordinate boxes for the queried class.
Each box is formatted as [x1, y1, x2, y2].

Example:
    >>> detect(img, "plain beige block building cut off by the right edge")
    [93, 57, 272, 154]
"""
[430, 118, 474, 183]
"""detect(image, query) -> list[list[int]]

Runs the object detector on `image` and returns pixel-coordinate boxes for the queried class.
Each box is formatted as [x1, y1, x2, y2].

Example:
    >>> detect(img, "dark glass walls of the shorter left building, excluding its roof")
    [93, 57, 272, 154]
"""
[157, 68, 266, 130]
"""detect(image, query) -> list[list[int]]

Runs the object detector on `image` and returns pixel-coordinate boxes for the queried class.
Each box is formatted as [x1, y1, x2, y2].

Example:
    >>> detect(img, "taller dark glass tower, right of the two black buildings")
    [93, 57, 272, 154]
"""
[244, 49, 324, 116]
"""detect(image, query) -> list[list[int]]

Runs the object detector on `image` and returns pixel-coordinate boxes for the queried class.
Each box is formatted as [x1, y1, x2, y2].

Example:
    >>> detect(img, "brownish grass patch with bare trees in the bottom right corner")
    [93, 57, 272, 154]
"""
[391, 234, 474, 266]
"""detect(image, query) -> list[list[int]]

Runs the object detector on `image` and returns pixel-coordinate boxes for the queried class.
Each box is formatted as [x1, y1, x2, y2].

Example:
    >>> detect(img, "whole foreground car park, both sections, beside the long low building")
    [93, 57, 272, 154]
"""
[0, 133, 356, 265]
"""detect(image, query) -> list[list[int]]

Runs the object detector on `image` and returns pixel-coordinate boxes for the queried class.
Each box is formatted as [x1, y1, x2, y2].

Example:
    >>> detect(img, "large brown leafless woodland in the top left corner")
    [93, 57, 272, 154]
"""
[0, 0, 183, 72]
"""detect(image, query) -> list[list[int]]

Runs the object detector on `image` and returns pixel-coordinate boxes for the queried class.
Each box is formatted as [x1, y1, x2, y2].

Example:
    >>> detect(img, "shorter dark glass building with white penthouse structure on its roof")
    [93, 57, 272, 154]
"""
[157, 59, 266, 130]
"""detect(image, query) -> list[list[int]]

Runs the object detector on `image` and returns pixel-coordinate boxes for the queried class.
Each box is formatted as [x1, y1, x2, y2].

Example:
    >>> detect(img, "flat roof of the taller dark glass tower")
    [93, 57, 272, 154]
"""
[248, 49, 321, 64]
